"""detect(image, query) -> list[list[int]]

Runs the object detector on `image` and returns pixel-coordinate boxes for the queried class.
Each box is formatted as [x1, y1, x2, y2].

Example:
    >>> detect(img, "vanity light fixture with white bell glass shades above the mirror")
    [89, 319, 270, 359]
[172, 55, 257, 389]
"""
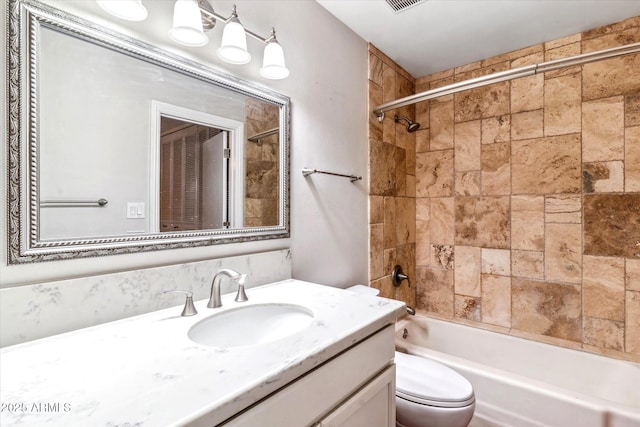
[96, 0, 289, 80]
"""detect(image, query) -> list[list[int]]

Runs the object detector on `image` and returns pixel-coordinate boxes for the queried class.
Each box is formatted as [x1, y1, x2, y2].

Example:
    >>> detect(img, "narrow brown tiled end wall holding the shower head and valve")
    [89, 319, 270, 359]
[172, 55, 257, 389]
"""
[369, 45, 422, 306]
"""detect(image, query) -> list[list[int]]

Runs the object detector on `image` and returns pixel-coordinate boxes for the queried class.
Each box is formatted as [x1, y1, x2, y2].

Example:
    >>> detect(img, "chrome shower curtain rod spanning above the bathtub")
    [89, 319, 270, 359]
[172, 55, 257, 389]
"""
[373, 43, 640, 121]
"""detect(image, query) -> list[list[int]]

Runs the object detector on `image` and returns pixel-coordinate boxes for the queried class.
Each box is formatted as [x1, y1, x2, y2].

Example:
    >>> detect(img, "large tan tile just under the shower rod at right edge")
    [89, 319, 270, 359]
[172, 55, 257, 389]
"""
[582, 55, 640, 101]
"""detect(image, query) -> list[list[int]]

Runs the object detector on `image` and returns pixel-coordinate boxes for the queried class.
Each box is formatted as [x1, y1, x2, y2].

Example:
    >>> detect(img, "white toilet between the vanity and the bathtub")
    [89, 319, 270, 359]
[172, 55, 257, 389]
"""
[347, 285, 476, 427]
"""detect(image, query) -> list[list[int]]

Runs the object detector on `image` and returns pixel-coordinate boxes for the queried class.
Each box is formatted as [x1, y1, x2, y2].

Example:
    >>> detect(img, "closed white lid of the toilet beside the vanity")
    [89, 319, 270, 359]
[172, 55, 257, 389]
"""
[395, 352, 475, 408]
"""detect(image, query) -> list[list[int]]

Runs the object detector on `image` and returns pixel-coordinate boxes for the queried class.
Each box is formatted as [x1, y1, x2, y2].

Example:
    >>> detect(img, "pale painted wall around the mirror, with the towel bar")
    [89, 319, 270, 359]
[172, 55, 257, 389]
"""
[0, 0, 368, 287]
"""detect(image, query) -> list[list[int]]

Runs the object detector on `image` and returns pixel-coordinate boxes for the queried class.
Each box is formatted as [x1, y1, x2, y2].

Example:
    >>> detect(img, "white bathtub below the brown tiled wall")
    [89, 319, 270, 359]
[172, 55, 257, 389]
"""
[396, 315, 640, 427]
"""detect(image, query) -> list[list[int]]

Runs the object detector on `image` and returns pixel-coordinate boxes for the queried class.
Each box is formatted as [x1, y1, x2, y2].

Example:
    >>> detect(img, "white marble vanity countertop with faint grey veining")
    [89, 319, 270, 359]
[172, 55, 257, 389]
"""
[0, 279, 405, 427]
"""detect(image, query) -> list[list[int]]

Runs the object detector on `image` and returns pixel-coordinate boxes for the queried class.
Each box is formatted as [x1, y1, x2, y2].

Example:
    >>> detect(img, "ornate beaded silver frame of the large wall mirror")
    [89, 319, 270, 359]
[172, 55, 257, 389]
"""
[6, 0, 291, 264]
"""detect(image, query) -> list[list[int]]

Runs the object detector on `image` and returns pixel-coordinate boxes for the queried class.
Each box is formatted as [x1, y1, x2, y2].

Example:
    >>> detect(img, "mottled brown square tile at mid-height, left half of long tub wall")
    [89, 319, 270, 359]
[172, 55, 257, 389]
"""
[455, 196, 511, 249]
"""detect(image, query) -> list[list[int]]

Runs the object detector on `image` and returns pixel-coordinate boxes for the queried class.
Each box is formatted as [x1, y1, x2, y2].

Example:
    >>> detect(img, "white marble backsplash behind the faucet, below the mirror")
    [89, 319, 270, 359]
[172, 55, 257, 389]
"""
[0, 250, 291, 347]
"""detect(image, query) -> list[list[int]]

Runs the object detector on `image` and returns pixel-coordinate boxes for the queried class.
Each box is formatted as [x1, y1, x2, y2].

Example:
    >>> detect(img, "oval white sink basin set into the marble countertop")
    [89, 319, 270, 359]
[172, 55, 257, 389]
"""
[188, 304, 313, 347]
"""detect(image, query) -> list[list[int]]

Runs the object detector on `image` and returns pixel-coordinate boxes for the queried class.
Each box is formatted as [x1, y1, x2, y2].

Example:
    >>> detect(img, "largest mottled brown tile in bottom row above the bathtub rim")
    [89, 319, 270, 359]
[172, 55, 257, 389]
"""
[512, 277, 582, 341]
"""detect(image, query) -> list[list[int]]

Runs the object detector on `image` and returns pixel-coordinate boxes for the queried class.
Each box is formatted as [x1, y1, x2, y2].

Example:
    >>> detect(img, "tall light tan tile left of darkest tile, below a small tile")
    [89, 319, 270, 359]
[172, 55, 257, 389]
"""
[544, 223, 582, 283]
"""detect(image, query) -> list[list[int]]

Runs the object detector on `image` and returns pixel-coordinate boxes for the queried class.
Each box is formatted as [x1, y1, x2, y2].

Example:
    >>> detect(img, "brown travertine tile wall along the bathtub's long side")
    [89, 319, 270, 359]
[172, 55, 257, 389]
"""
[370, 17, 640, 360]
